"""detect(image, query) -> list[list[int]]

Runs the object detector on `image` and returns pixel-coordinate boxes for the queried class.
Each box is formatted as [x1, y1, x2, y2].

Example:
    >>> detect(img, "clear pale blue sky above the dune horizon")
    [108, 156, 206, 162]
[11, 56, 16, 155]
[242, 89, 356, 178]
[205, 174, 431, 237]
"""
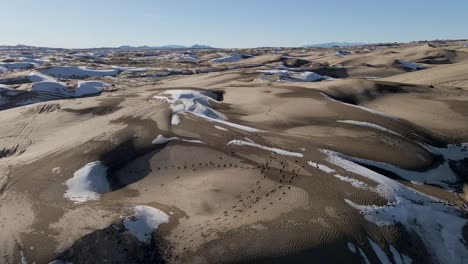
[0, 0, 468, 48]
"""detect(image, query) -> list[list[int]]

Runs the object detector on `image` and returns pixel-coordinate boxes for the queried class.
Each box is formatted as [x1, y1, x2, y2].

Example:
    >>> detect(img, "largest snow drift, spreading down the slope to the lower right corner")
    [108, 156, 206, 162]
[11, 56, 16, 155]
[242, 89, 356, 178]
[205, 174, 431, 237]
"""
[323, 150, 468, 263]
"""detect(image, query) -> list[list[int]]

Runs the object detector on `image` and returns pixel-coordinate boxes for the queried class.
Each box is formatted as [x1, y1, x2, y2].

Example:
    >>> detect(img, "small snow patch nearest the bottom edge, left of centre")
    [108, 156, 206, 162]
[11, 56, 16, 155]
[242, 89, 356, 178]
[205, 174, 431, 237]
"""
[123, 205, 169, 242]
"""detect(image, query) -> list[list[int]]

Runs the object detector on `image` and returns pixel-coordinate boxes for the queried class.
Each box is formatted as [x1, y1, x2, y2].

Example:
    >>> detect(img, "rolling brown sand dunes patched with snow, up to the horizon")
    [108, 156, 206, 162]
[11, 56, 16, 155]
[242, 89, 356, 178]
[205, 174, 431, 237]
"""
[0, 42, 468, 264]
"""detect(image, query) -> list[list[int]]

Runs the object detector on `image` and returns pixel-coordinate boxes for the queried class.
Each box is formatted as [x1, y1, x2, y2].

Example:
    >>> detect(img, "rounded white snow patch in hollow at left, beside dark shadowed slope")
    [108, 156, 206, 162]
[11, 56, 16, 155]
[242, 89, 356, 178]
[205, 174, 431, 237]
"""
[64, 161, 110, 203]
